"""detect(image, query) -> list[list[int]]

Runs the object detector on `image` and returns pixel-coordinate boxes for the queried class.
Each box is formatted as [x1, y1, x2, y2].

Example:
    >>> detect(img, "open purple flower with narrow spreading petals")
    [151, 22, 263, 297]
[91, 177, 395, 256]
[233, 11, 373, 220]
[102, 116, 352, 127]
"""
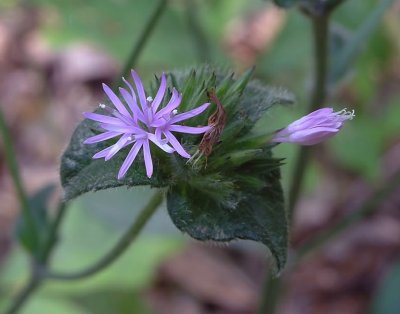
[83, 70, 210, 179]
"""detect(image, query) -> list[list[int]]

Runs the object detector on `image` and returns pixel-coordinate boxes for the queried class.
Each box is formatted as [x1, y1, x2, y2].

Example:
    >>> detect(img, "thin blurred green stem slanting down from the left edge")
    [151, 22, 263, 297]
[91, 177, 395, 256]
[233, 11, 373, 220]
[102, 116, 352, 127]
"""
[0, 107, 38, 248]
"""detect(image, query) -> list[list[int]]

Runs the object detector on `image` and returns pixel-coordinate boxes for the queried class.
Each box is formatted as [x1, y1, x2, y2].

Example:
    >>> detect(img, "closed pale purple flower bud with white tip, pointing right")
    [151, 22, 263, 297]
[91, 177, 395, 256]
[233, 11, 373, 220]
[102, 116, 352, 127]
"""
[272, 108, 354, 145]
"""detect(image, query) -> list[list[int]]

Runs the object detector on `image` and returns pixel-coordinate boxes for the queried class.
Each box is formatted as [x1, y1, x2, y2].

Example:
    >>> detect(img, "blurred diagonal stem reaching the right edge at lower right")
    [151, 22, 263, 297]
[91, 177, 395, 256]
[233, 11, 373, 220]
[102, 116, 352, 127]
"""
[297, 170, 400, 260]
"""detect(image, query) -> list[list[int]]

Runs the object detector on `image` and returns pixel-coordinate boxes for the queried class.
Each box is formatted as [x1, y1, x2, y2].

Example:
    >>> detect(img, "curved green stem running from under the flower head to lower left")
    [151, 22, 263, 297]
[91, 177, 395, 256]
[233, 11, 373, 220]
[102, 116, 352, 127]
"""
[42, 191, 164, 280]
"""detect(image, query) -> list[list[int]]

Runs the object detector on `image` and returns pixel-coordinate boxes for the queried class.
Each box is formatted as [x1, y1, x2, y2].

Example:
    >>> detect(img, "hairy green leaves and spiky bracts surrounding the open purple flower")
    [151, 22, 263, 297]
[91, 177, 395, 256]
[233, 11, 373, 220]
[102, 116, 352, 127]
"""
[61, 66, 293, 270]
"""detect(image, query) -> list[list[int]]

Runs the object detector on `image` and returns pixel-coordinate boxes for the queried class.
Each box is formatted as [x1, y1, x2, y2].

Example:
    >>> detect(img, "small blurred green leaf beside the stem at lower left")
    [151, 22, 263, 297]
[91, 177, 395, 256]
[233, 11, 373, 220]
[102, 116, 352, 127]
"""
[16, 184, 55, 254]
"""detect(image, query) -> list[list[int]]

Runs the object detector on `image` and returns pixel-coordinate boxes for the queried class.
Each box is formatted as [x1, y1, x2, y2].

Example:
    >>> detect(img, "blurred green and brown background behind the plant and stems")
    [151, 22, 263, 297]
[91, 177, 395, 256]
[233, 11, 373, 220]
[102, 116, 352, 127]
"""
[0, 0, 400, 314]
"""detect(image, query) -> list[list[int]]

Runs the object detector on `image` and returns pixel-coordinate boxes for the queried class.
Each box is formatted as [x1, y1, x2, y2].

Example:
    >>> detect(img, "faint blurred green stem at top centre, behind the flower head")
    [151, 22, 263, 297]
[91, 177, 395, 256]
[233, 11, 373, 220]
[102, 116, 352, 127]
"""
[185, 0, 211, 62]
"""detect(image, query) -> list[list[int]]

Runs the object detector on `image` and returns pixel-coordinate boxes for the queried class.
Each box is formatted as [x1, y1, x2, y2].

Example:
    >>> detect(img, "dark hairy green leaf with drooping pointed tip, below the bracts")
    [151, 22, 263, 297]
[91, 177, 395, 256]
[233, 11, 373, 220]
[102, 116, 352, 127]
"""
[167, 156, 288, 271]
